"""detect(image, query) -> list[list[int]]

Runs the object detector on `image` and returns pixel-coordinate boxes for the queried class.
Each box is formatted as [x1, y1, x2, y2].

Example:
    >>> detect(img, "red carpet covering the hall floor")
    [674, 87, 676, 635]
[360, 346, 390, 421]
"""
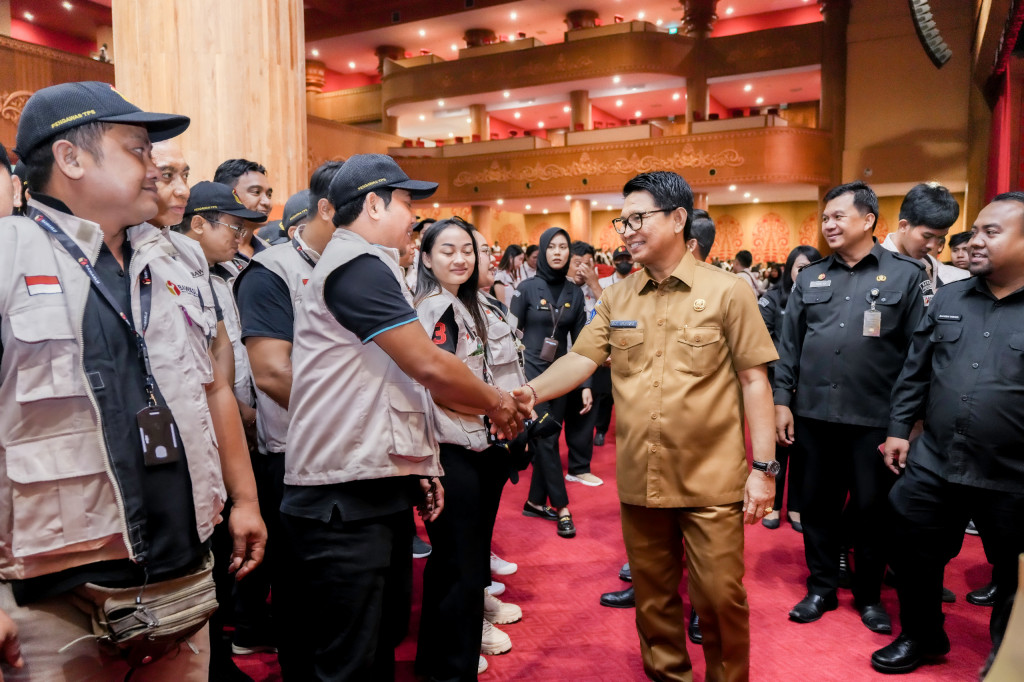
[236, 419, 991, 682]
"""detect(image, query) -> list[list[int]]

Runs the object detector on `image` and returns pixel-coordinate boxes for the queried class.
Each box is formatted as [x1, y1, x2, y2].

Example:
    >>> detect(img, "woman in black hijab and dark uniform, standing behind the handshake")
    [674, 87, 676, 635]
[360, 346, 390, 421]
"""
[510, 227, 590, 538]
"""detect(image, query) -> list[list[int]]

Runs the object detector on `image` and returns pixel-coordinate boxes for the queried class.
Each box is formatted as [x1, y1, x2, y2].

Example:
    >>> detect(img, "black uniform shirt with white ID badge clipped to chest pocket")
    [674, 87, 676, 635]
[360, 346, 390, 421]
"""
[775, 244, 925, 427]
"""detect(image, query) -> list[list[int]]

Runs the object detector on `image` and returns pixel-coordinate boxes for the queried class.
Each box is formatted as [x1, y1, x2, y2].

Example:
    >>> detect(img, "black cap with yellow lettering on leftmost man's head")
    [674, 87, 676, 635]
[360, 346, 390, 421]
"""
[15, 81, 188, 159]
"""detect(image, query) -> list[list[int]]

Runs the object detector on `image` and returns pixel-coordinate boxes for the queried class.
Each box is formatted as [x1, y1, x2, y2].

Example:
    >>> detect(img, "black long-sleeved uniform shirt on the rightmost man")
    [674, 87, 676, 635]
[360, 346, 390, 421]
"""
[889, 278, 1024, 493]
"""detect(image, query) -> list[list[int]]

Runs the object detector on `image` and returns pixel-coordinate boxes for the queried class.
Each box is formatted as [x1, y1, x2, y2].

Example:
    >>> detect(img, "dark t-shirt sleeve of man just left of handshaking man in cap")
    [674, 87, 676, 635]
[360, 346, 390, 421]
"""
[234, 261, 295, 343]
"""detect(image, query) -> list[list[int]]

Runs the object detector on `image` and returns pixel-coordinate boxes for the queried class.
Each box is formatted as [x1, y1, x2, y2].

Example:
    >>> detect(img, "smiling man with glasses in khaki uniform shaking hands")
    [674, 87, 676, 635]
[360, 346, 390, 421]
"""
[516, 171, 778, 681]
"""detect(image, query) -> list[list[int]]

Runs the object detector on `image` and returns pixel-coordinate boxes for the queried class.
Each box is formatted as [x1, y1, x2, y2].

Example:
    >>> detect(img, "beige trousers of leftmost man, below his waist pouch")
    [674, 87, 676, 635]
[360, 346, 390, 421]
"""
[0, 583, 210, 682]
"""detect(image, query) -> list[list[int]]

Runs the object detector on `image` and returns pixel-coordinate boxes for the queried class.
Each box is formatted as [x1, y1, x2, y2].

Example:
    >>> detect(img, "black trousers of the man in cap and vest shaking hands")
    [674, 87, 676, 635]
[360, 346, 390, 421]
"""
[279, 509, 414, 682]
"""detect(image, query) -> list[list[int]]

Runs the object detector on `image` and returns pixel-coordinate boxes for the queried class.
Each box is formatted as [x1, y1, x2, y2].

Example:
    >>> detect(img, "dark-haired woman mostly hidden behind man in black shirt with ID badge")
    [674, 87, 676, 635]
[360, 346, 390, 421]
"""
[758, 245, 821, 532]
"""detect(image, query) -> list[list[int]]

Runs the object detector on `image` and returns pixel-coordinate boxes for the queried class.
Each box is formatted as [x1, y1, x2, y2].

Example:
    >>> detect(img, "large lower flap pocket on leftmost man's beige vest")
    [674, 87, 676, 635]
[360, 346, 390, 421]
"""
[6, 433, 121, 557]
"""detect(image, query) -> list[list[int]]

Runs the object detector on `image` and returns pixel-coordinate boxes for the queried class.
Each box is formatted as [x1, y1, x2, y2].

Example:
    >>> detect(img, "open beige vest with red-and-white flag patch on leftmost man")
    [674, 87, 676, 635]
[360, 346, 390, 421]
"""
[0, 202, 225, 580]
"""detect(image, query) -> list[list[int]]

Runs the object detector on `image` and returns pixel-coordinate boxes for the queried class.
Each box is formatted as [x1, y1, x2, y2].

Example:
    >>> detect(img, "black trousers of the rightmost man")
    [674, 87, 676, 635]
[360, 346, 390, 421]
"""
[889, 458, 1024, 647]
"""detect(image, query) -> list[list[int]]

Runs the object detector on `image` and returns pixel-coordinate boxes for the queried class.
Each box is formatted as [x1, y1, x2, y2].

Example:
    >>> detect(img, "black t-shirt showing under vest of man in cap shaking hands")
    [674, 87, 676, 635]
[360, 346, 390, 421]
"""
[280, 254, 421, 522]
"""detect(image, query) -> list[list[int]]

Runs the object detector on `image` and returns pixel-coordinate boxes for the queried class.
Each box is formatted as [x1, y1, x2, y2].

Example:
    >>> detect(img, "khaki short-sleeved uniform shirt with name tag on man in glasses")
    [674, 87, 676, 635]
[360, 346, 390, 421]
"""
[572, 252, 778, 507]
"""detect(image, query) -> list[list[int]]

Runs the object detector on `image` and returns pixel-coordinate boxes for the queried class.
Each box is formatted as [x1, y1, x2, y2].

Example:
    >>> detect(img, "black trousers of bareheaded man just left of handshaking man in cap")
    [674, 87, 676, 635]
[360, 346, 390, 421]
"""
[234, 452, 287, 642]
